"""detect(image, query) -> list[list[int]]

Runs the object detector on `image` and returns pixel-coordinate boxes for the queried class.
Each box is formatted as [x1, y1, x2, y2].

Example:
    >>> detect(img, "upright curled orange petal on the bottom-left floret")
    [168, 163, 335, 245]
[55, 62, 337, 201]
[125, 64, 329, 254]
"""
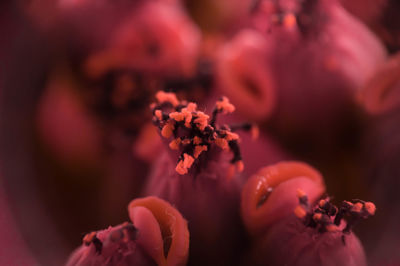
[128, 197, 189, 266]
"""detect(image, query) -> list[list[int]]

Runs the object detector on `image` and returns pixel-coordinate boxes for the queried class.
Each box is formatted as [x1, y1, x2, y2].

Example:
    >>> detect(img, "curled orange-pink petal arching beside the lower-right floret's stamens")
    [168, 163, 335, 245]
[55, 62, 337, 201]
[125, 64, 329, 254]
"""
[241, 161, 325, 237]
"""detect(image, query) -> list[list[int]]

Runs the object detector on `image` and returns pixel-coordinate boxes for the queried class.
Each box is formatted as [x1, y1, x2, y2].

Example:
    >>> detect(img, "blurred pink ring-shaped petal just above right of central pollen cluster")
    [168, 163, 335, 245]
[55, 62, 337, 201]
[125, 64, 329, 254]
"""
[216, 30, 277, 121]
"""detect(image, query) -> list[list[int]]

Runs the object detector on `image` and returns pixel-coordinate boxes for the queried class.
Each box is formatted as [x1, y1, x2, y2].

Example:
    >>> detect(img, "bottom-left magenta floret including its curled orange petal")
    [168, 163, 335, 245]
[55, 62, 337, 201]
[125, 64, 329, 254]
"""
[67, 197, 189, 266]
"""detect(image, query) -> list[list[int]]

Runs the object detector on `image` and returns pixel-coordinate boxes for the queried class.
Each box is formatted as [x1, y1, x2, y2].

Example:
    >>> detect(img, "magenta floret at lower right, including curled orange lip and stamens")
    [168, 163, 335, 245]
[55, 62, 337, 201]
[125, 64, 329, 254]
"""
[241, 162, 376, 266]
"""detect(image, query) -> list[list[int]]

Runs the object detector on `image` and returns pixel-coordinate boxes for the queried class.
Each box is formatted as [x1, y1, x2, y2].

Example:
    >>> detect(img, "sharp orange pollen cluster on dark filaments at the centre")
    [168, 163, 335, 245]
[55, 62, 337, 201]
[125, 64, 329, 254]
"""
[150, 91, 245, 175]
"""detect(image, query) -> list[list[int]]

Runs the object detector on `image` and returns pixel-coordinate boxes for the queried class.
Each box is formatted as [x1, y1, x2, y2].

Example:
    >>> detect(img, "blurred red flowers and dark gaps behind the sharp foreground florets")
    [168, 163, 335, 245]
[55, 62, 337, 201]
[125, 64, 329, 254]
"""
[0, 0, 400, 265]
